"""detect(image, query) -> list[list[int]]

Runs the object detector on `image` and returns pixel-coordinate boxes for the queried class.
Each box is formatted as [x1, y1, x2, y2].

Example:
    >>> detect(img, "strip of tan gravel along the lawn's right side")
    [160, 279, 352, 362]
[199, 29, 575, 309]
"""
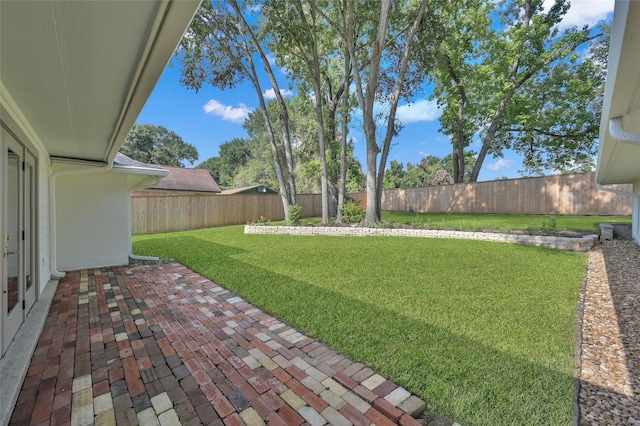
[578, 239, 640, 426]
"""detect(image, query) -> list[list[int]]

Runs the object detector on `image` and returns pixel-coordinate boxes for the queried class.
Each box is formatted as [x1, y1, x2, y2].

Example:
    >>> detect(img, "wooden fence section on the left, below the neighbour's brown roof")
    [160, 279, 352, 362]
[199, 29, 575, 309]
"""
[131, 194, 322, 235]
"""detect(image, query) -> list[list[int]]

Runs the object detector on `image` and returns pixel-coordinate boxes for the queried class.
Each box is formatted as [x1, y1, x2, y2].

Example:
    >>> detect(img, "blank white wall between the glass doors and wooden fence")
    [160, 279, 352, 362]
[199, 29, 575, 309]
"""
[55, 172, 131, 271]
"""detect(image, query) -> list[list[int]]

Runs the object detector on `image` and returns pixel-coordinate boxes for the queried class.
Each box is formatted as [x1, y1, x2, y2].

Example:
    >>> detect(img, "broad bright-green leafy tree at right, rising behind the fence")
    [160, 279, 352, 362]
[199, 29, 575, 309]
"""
[425, 0, 606, 182]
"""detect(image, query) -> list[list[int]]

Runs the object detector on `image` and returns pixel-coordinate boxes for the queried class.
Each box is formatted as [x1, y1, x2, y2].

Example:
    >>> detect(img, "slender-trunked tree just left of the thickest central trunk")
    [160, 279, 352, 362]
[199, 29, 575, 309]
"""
[263, 0, 358, 222]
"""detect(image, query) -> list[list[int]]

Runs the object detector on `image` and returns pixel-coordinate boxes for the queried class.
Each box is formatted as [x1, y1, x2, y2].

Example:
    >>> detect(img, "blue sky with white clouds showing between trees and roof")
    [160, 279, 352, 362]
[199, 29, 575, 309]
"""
[137, 0, 613, 181]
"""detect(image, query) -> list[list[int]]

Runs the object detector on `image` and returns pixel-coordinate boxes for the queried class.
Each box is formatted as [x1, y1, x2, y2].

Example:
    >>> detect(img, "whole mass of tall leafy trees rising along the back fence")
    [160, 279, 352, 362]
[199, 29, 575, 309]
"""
[179, 0, 608, 224]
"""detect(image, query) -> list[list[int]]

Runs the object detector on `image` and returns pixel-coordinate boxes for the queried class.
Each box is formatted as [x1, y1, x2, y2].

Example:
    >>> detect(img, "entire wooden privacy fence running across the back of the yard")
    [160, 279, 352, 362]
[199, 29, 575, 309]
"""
[131, 173, 632, 234]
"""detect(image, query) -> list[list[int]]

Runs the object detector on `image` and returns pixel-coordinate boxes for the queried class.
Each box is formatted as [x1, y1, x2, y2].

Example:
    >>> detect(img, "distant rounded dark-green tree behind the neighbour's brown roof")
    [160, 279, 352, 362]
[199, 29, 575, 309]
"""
[120, 124, 198, 167]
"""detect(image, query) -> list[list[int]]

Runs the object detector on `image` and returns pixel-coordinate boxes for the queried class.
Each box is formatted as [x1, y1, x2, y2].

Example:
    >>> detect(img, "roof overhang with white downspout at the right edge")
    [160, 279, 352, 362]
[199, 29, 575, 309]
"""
[596, 0, 640, 185]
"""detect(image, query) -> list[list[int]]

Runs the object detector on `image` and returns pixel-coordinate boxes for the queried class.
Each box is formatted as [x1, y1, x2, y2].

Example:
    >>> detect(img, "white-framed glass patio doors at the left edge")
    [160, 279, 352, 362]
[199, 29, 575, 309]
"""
[0, 129, 37, 353]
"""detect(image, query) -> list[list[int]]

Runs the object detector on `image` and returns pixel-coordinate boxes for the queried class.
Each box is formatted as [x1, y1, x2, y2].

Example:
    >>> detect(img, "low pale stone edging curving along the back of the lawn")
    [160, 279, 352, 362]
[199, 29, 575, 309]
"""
[244, 225, 599, 252]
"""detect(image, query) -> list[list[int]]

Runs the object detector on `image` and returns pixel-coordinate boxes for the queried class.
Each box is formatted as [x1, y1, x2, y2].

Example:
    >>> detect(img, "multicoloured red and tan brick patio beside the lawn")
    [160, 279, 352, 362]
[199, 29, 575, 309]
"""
[10, 263, 424, 426]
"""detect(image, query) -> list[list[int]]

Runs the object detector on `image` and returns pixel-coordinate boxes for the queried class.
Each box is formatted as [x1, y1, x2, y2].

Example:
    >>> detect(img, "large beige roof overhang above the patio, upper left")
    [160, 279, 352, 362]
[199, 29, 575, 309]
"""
[0, 0, 201, 162]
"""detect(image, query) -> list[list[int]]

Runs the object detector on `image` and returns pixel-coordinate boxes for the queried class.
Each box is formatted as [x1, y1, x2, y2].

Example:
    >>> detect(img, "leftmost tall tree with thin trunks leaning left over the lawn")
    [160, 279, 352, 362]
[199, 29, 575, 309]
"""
[180, 0, 296, 221]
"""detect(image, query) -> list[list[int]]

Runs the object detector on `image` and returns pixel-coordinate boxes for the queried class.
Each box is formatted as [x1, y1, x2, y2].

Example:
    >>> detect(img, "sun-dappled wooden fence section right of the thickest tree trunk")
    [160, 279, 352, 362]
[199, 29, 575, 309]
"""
[351, 172, 632, 216]
